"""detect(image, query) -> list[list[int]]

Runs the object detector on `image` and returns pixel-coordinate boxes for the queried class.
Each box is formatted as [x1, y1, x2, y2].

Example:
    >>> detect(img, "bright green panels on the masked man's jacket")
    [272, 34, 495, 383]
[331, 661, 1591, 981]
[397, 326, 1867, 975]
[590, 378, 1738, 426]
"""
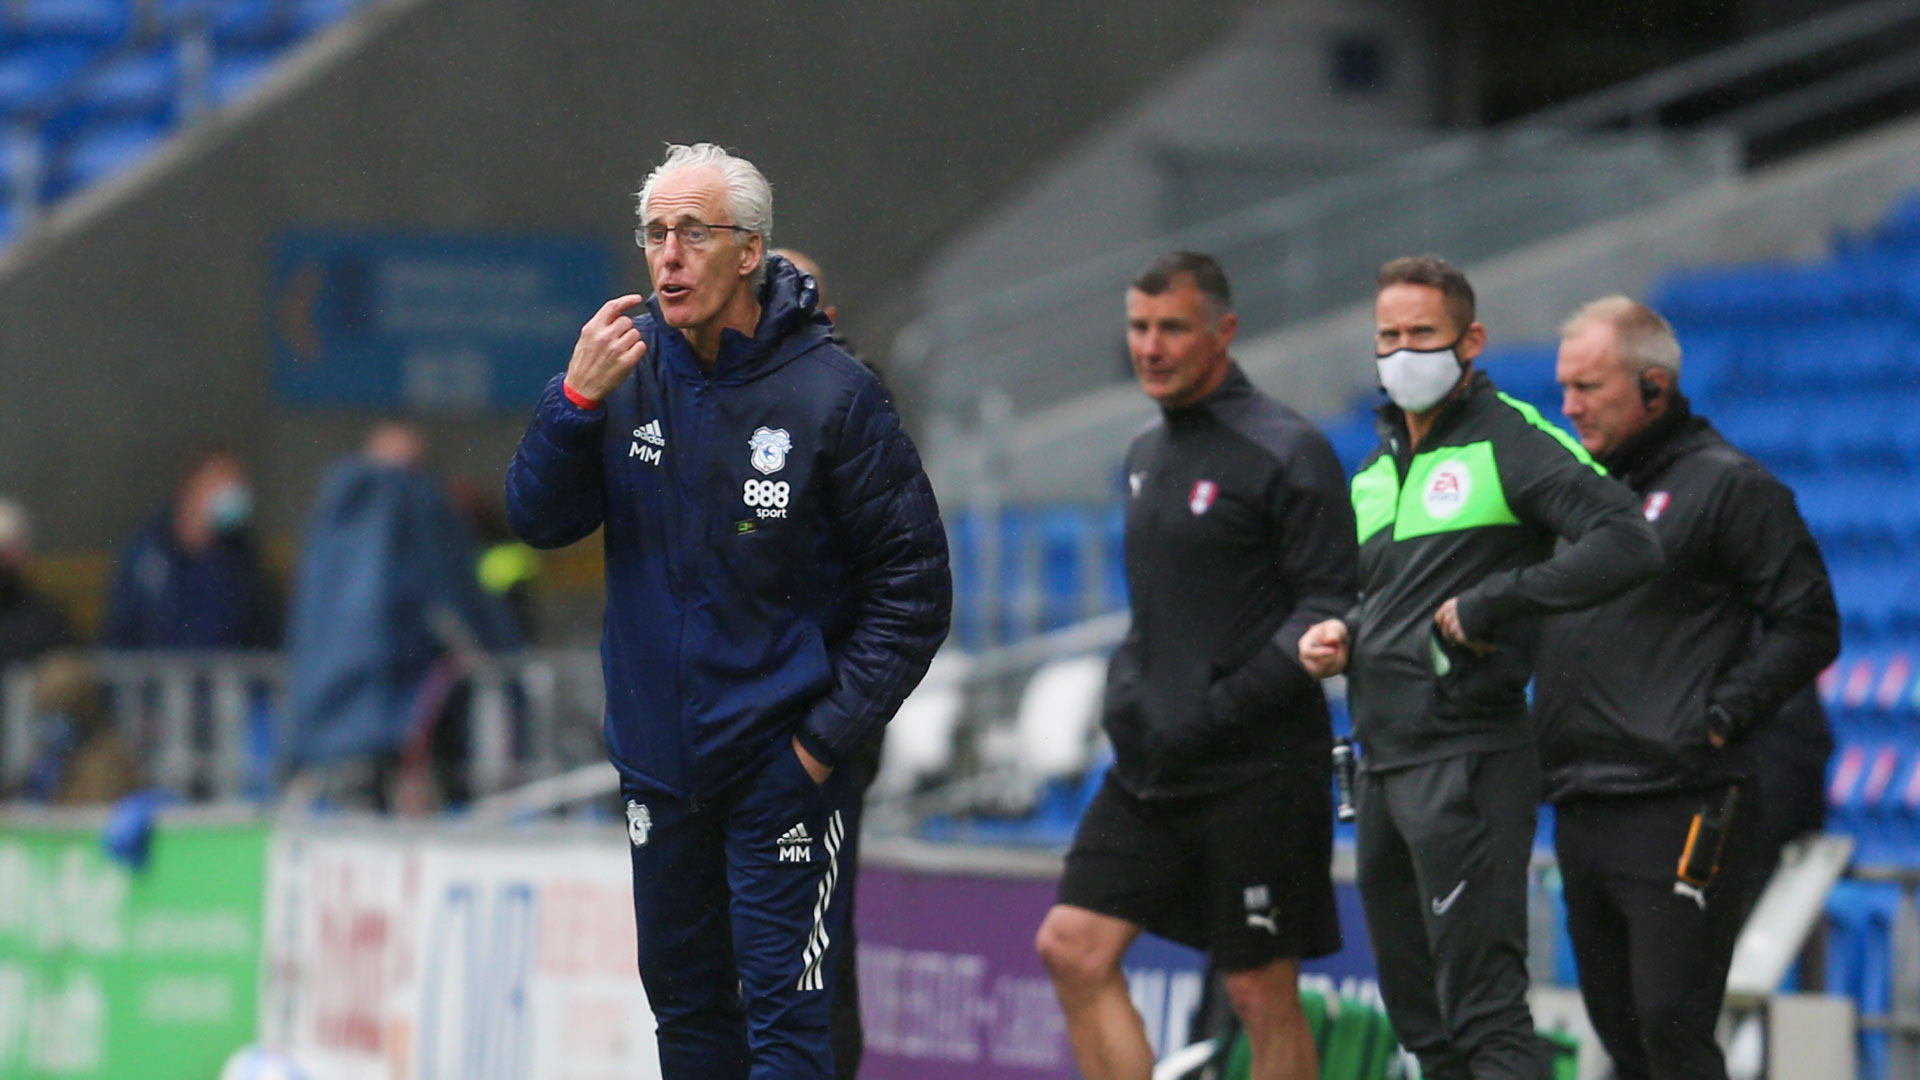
[1354, 394, 1607, 544]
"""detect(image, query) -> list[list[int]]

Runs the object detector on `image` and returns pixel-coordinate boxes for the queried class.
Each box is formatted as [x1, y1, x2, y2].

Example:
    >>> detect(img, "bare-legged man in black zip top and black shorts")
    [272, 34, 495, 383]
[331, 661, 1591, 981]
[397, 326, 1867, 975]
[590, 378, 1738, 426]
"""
[1037, 252, 1354, 1080]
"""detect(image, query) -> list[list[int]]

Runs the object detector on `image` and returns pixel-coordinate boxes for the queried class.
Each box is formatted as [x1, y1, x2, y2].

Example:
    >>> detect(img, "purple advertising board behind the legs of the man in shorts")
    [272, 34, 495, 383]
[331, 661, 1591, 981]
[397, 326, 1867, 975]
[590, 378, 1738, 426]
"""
[854, 849, 1377, 1080]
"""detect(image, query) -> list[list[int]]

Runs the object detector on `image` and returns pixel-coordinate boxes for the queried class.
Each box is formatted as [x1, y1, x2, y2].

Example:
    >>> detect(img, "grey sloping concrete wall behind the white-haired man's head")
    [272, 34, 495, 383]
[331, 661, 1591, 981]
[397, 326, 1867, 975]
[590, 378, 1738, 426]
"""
[0, 0, 1250, 552]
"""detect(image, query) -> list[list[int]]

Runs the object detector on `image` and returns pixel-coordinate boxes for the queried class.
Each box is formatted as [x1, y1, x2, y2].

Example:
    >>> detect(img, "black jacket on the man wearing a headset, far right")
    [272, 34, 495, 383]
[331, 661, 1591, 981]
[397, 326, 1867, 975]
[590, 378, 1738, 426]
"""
[1534, 400, 1839, 801]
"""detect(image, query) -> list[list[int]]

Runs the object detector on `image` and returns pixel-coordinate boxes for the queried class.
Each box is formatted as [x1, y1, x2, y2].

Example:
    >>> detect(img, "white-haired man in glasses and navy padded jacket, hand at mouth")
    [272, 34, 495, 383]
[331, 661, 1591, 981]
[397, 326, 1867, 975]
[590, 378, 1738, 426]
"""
[507, 142, 952, 1080]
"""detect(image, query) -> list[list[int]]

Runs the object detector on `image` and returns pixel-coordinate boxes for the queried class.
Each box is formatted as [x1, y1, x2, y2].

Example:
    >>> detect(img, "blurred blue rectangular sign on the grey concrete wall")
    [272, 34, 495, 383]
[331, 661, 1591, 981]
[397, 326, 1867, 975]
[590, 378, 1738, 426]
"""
[267, 233, 616, 415]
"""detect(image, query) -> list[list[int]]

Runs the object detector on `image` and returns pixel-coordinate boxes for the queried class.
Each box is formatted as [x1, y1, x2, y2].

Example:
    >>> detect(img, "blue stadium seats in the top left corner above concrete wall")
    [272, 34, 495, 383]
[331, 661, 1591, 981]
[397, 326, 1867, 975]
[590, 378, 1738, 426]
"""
[0, 0, 367, 234]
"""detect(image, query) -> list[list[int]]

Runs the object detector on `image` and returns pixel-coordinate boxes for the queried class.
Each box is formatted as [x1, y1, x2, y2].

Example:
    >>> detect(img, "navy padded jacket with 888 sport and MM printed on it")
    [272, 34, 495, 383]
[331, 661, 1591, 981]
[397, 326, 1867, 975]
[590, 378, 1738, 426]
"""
[507, 256, 952, 798]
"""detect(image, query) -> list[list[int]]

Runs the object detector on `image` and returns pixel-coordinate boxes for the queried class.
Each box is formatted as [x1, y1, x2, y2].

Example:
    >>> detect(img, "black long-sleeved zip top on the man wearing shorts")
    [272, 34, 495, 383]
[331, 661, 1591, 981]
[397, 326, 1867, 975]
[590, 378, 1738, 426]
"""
[1106, 365, 1354, 798]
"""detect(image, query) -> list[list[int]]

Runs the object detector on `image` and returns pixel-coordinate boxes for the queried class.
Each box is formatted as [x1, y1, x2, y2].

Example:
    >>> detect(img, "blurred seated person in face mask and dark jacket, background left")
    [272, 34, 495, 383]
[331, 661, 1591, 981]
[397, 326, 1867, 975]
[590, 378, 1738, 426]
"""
[100, 448, 280, 650]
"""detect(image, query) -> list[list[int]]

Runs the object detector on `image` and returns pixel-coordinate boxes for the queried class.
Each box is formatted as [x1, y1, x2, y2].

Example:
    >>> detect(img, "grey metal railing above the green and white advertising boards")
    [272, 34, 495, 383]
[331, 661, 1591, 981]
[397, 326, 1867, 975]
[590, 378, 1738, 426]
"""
[0, 650, 605, 801]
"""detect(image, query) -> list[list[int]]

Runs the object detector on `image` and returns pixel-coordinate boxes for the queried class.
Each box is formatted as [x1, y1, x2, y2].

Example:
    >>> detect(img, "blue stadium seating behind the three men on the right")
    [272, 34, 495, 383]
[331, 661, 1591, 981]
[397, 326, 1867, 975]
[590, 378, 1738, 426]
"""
[927, 182, 1920, 1080]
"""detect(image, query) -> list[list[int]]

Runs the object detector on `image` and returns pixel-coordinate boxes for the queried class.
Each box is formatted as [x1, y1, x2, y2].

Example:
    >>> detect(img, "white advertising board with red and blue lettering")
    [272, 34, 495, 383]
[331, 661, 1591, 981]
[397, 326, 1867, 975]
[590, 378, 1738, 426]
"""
[261, 830, 660, 1080]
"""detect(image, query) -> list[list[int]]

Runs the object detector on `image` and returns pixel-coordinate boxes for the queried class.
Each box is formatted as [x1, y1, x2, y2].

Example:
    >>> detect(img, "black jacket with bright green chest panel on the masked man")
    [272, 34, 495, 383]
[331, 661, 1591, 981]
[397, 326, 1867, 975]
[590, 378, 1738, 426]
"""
[1346, 371, 1661, 771]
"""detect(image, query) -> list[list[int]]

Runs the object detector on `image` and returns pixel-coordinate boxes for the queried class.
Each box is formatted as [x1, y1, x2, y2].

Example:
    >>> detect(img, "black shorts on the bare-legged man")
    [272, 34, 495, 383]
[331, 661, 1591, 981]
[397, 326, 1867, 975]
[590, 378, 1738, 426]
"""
[1060, 774, 1340, 970]
